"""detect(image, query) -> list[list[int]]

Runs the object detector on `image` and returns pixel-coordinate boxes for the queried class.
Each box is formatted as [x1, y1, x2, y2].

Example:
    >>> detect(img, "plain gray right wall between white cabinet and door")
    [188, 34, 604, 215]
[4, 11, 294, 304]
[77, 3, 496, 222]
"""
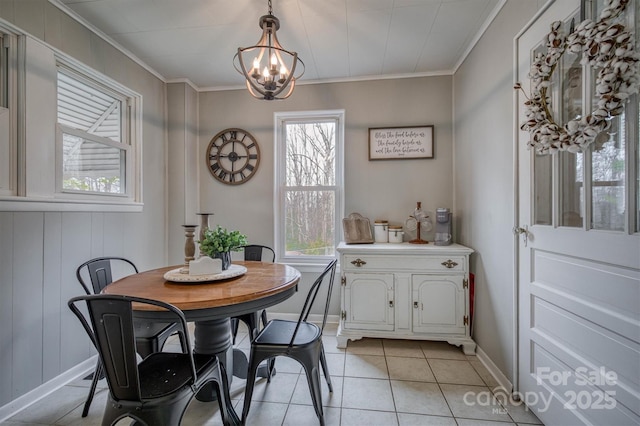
[454, 0, 543, 383]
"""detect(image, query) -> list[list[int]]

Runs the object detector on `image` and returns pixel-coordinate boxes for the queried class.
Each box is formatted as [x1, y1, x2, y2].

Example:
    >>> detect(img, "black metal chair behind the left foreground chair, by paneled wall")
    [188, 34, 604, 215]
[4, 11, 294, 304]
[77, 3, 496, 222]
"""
[76, 256, 184, 417]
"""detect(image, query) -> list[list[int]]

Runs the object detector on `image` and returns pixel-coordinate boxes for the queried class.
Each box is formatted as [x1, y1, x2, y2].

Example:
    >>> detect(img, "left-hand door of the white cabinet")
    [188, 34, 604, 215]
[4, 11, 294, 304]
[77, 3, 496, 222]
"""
[344, 273, 393, 331]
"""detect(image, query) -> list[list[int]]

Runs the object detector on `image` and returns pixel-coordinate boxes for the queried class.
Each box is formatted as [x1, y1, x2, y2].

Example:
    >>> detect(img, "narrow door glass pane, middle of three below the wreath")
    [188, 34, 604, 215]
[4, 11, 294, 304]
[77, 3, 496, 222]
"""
[558, 152, 584, 228]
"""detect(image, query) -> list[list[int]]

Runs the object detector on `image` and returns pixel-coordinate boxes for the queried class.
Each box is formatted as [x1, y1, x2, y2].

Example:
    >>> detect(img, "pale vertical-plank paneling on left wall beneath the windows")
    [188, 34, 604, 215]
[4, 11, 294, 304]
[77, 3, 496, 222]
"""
[0, 212, 170, 405]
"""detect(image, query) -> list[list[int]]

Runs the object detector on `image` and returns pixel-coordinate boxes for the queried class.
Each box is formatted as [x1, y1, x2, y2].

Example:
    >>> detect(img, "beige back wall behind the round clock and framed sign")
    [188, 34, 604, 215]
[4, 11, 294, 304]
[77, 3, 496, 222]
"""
[199, 76, 455, 315]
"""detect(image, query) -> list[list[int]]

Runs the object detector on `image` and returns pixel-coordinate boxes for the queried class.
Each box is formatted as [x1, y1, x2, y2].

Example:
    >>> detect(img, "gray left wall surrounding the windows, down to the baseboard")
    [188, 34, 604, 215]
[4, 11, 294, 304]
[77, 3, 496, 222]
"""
[0, 0, 167, 406]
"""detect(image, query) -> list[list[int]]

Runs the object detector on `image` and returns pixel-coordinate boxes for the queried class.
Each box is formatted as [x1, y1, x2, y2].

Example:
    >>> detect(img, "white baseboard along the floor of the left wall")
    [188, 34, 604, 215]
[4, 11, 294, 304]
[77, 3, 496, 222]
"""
[0, 355, 98, 423]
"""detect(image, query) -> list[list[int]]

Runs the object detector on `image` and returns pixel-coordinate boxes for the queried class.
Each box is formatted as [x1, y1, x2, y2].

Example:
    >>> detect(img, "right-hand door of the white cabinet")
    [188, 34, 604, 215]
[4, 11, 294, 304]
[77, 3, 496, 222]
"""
[411, 275, 465, 334]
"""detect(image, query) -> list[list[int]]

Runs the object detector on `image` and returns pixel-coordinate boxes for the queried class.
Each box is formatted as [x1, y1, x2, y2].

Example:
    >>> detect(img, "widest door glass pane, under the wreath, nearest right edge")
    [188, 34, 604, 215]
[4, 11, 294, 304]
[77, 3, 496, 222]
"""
[591, 113, 626, 231]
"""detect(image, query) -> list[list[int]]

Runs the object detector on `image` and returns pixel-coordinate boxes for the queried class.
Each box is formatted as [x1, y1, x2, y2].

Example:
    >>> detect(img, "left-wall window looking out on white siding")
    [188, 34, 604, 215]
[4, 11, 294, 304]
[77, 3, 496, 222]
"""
[57, 66, 133, 195]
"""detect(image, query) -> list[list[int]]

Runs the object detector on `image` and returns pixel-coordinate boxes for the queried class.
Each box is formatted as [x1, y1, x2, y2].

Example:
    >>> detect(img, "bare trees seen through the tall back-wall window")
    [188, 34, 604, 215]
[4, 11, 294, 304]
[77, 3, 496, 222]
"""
[284, 120, 336, 256]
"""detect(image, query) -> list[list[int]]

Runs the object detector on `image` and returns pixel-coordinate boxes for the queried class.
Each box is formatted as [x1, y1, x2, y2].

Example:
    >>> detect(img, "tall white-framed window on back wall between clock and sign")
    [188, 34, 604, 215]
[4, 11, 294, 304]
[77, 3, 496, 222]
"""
[275, 110, 344, 263]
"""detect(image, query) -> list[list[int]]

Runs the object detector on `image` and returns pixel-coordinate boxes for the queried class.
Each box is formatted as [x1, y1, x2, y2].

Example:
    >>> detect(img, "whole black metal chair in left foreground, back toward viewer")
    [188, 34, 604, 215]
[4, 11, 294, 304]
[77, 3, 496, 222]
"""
[68, 294, 239, 426]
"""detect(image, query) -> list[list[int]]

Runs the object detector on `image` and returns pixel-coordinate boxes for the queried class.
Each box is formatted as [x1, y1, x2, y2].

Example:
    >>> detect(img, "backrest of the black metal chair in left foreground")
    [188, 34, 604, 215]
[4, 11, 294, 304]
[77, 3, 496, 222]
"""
[68, 294, 196, 401]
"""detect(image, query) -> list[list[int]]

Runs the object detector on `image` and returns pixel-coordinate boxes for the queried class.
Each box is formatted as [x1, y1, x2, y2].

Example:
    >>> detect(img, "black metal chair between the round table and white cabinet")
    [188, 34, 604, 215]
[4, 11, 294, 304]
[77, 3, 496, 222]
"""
[242, 259, 337, 425]
